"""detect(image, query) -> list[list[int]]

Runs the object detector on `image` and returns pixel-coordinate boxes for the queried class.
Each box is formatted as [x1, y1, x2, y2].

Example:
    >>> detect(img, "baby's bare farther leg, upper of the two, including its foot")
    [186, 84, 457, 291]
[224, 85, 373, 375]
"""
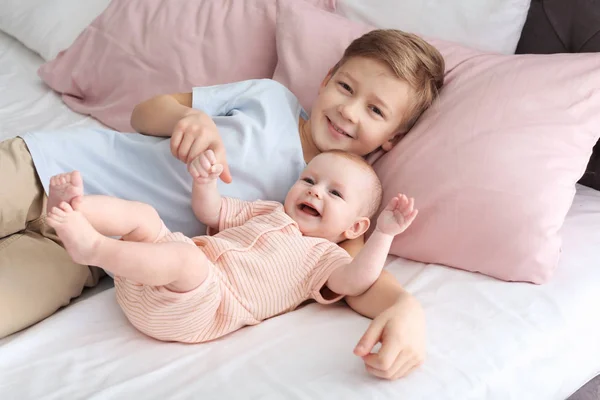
[47, 171, 162, 242]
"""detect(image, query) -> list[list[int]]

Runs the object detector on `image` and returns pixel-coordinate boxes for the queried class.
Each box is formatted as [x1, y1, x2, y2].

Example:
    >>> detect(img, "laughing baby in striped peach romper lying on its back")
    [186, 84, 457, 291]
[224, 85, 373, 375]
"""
[47, 150, 417, 343]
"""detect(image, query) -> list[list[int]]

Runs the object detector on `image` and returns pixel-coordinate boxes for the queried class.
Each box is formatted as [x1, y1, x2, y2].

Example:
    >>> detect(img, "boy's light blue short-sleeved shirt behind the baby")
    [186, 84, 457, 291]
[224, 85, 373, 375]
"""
[22, 79, 306, 236]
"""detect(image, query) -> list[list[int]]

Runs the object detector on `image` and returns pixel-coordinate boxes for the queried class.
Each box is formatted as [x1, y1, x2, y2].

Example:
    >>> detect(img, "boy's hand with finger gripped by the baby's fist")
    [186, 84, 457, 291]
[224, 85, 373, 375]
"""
[171, 110, 231, 183]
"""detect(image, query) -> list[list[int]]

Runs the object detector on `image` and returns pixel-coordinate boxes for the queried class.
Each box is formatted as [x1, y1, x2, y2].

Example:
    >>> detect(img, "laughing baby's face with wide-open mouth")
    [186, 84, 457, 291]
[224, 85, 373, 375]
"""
[284, 154, 373, 243]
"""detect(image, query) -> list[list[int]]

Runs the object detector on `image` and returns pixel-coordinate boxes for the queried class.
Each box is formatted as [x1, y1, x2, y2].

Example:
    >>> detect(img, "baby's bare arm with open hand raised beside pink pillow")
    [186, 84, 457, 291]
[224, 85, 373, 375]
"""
[327, 194, 418, 296]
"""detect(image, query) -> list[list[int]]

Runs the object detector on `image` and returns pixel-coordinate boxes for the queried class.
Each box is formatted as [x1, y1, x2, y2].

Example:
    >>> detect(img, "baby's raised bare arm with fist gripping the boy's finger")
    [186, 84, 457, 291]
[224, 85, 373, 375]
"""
[188, 150, 223, 229]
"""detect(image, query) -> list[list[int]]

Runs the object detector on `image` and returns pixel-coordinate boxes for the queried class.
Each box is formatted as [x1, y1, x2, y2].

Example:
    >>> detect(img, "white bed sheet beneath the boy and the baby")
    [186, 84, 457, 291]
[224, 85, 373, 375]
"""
[0, 0, 600, 400]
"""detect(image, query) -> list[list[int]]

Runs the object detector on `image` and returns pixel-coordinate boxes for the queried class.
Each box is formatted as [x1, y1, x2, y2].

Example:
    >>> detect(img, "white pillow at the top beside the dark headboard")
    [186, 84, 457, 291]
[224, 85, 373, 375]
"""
[337, 0, 531, 54]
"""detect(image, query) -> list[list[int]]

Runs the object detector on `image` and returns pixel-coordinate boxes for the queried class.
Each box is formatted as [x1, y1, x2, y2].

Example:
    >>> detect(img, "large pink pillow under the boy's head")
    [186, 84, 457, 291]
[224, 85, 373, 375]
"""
[275, 3, 600, 283]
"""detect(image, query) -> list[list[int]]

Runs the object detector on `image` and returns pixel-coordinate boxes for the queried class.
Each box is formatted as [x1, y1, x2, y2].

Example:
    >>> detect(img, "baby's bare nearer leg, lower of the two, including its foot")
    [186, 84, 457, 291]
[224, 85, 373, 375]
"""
[47, 202, 210, 292]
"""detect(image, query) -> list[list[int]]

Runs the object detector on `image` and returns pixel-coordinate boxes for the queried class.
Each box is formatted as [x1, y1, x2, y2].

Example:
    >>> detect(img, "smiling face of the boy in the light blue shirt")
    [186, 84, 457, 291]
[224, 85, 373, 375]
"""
[310, 57, 413, 156]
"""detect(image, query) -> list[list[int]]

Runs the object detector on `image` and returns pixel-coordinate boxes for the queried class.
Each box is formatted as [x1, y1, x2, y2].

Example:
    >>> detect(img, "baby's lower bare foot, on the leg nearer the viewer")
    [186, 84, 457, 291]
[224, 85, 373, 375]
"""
[46, 201, 104, 265]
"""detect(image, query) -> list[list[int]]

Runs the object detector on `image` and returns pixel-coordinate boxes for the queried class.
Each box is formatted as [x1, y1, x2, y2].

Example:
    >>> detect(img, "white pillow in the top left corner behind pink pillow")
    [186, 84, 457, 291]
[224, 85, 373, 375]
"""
[0, 0, 110, 61]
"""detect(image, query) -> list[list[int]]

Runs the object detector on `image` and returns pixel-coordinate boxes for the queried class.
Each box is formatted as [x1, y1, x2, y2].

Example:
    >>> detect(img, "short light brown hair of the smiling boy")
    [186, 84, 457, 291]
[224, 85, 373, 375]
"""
[331, 29, 445, 132]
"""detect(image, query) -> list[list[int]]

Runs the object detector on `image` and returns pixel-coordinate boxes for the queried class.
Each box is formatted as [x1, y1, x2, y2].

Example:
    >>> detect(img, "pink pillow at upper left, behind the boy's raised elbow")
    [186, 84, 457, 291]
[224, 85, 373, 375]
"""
[39, 0, 335, 131]
